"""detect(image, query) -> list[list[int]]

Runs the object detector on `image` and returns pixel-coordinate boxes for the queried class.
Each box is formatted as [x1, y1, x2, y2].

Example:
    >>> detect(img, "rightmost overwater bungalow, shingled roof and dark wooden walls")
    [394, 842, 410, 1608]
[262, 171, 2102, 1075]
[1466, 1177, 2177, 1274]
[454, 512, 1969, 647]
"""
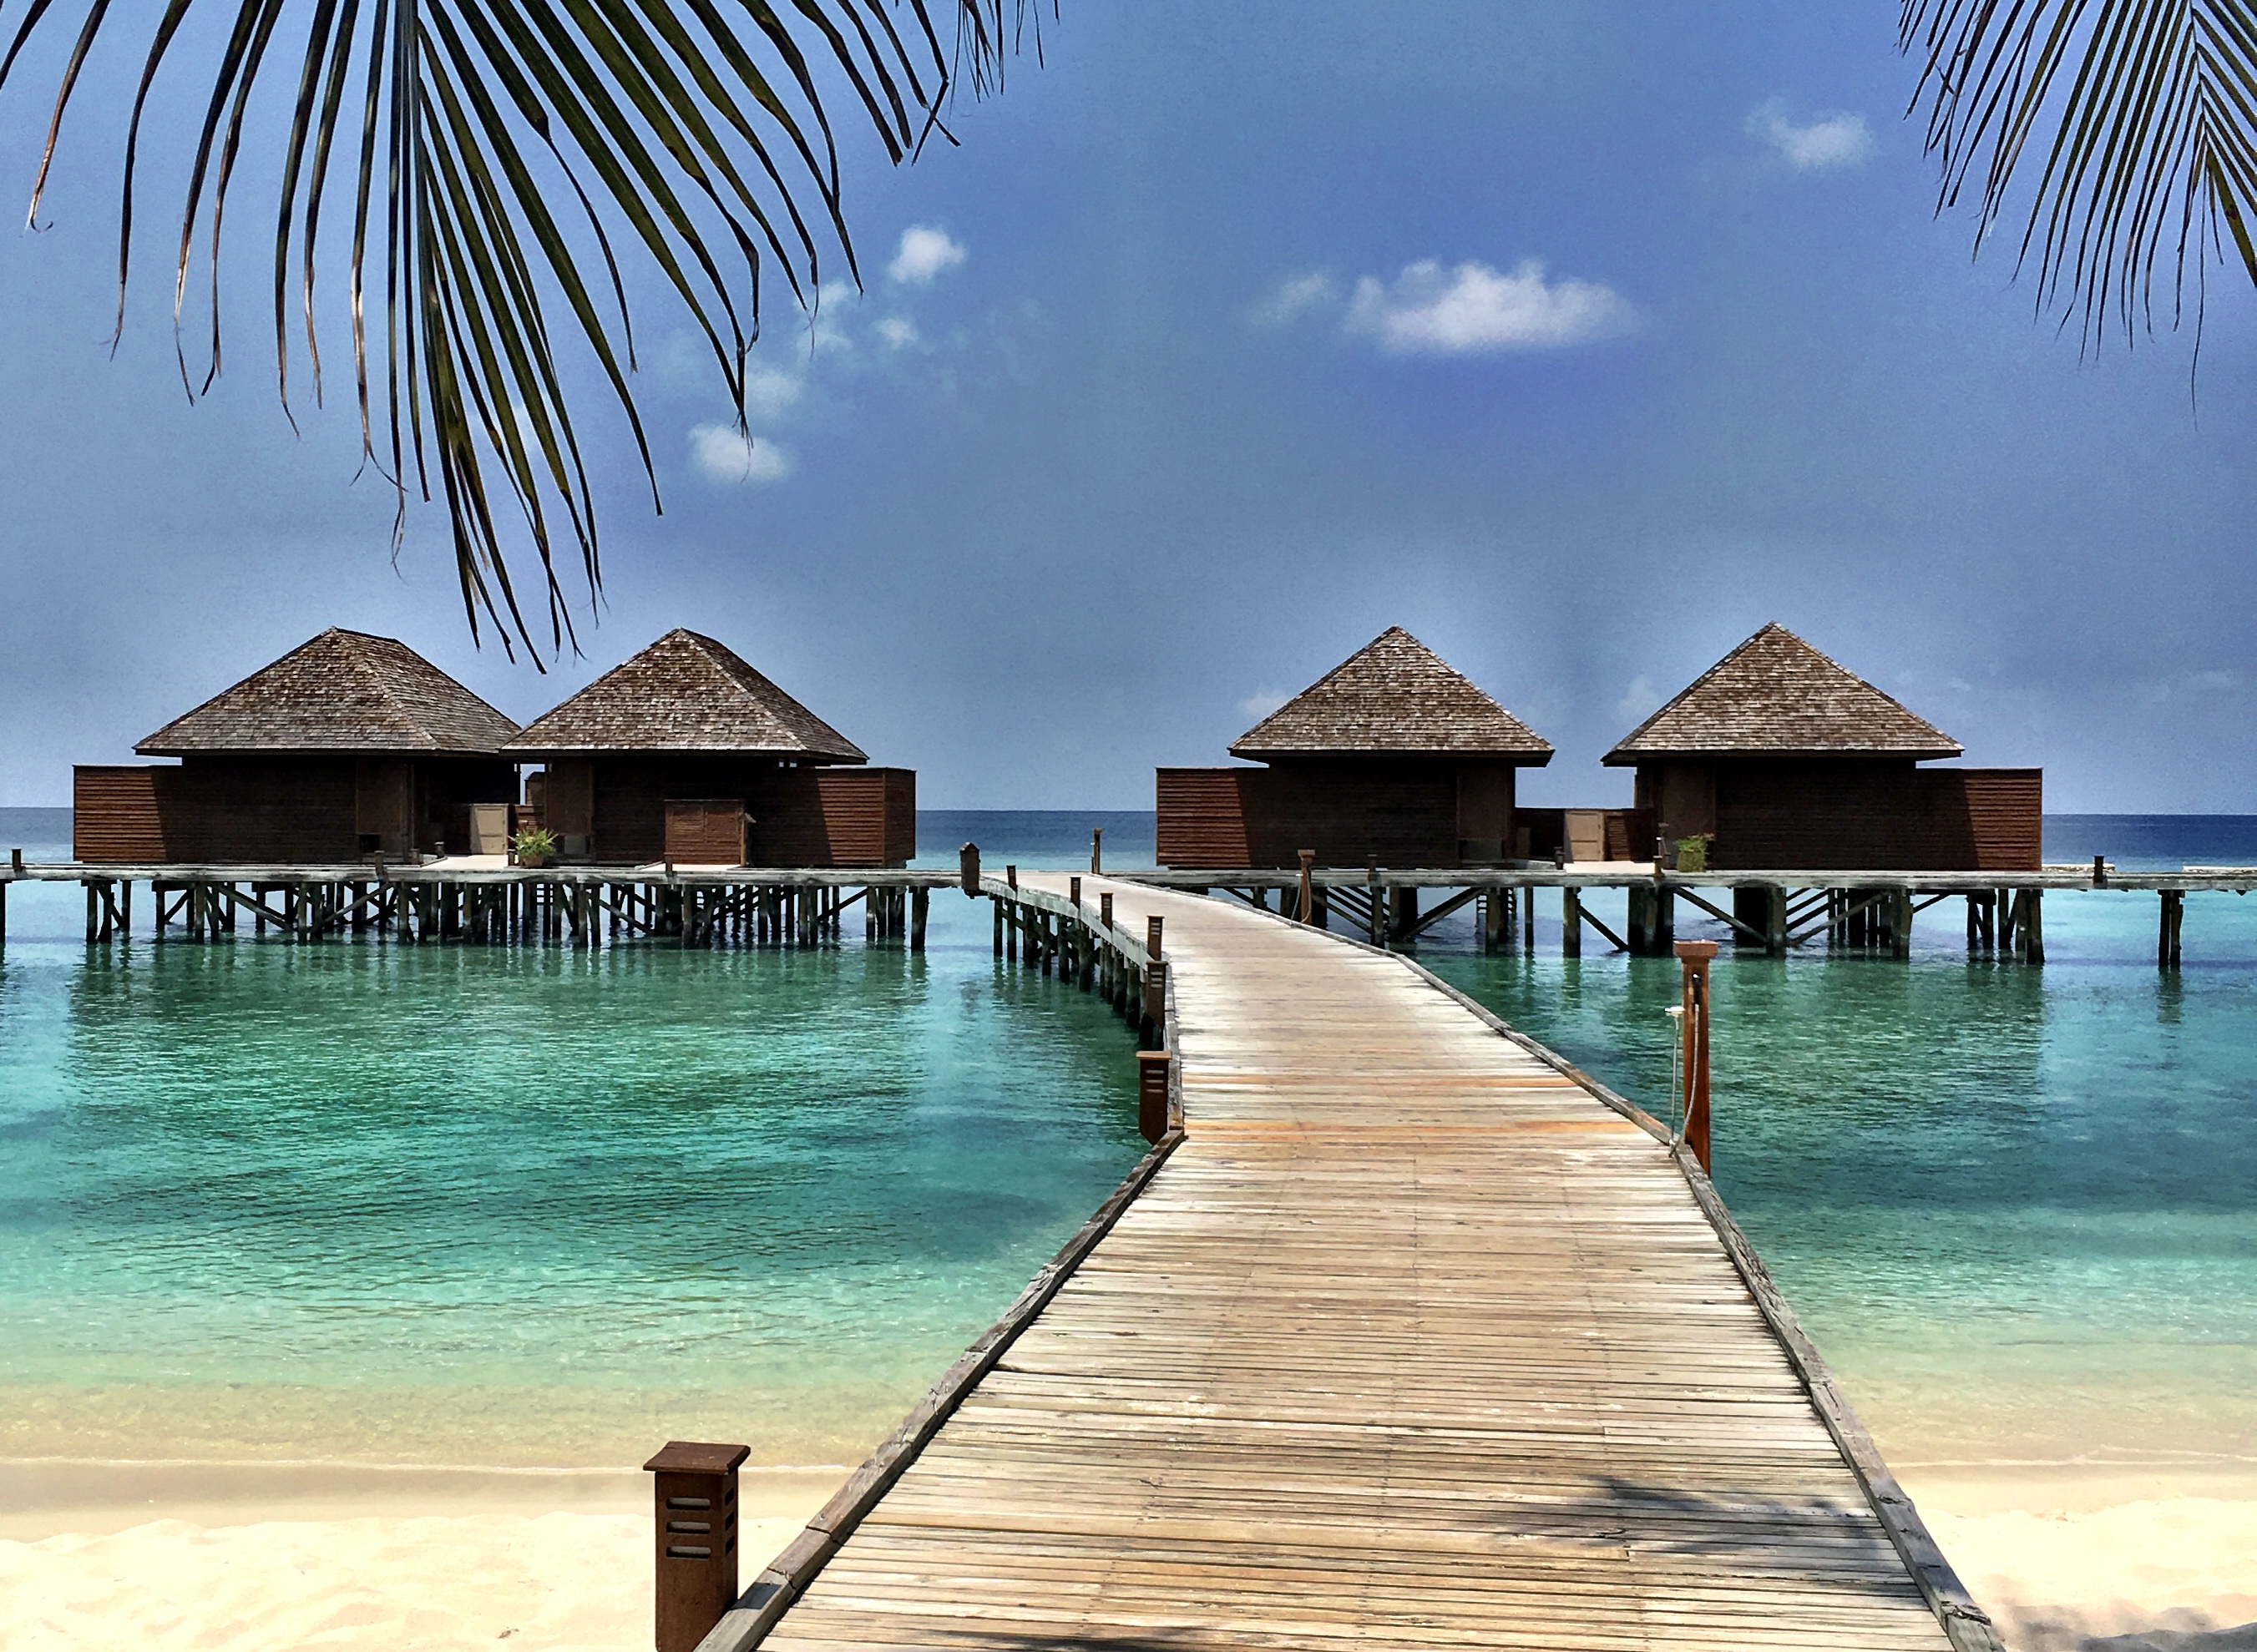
[1605, 625, 2045, 871]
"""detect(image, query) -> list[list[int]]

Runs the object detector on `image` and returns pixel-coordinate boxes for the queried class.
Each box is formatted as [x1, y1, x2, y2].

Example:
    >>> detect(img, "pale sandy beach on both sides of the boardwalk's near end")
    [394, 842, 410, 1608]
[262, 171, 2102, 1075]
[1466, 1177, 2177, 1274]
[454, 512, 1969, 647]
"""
[0, 1460, 2257, 1652]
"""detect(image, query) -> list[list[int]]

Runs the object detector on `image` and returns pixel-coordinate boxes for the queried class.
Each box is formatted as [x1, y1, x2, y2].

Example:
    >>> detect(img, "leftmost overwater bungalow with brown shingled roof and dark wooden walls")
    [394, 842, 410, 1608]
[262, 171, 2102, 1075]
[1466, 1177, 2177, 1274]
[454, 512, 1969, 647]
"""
[72, 629, 517, 864]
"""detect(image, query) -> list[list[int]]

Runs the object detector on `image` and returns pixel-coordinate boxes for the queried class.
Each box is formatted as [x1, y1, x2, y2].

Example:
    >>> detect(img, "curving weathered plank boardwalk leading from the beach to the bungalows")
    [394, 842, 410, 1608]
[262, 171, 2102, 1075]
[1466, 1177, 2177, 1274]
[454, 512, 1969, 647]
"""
[726, 876, 1995, 1652]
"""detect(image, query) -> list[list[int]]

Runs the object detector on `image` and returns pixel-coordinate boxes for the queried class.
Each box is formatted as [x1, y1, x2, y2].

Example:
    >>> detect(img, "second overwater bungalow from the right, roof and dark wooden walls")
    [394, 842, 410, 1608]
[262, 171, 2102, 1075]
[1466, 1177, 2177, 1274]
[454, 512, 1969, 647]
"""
[1158, 625, 1553, 866]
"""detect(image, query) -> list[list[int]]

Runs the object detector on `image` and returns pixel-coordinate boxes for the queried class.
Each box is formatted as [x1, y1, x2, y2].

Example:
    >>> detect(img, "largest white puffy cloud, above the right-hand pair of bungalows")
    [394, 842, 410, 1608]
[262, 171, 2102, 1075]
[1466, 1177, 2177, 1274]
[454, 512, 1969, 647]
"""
[1348, 257, 1638, 356]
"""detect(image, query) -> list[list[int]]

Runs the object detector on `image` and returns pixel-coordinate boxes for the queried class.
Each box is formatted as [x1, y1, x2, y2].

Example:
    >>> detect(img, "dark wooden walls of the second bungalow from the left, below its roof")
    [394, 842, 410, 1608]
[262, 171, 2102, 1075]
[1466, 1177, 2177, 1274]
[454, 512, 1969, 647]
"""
[529, 751, 916, 866]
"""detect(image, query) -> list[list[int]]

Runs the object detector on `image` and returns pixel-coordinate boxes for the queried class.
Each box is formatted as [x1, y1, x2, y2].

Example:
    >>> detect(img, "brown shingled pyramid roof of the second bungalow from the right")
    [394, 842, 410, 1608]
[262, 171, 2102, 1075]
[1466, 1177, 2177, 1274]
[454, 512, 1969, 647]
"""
[1230, 625, 1553, 765]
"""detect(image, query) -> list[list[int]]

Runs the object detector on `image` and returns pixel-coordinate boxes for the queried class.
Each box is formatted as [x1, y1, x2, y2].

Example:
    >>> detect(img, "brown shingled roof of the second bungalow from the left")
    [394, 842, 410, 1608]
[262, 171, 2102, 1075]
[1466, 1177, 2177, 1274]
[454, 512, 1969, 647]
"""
[508, 629, 869, 763]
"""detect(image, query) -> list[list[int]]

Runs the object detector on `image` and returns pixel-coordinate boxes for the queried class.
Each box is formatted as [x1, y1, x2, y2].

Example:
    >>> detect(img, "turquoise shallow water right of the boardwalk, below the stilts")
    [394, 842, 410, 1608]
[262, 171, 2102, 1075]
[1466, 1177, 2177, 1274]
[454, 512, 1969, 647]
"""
[1422, 857, 2257, 1465]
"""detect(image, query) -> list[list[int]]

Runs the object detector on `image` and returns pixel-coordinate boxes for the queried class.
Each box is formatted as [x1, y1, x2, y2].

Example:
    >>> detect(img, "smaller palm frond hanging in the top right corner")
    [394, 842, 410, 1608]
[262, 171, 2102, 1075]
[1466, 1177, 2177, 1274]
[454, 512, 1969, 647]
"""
[1900, 0, 2257, 346]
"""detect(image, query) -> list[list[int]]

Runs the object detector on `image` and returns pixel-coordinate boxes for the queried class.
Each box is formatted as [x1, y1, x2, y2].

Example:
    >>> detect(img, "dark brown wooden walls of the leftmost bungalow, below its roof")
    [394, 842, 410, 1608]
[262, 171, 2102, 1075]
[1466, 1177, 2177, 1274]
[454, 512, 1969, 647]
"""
[70, 754, 517, 864]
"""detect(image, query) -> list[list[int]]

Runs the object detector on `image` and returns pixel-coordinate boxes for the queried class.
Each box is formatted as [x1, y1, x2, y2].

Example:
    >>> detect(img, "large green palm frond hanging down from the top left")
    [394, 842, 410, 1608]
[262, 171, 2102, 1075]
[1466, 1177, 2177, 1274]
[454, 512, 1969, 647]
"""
[0, 0, 1038, 664]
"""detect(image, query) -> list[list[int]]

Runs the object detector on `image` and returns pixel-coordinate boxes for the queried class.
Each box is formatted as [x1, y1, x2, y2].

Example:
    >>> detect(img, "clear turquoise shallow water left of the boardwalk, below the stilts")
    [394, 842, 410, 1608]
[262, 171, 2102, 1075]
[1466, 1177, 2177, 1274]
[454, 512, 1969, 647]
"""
[0, 839, 1142, 1465]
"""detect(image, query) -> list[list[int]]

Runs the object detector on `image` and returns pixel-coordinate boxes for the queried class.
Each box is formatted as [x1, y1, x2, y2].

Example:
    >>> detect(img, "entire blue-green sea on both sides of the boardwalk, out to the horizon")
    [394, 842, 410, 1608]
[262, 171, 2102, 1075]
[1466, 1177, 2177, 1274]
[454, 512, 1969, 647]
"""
[0, 811, 2257, 1467]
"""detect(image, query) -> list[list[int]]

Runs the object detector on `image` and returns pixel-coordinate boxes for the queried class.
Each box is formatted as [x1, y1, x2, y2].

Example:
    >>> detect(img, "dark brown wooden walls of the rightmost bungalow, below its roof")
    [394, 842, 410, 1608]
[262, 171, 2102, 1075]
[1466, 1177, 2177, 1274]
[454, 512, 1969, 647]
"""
[1637, 756, 2045, 871]
